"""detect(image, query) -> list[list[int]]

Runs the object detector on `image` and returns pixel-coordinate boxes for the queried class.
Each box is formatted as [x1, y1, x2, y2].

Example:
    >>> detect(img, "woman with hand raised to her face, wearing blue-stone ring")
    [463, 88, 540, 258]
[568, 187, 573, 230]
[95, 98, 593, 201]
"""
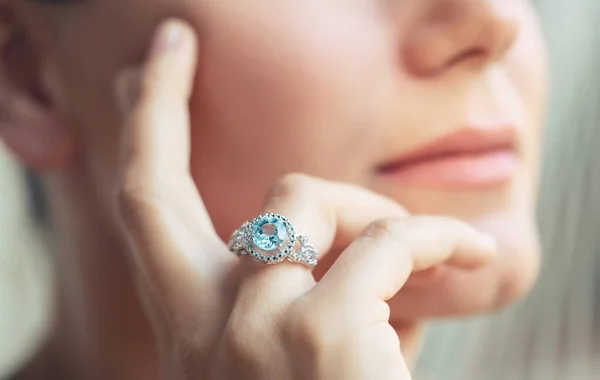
[0, 0, 545, 379]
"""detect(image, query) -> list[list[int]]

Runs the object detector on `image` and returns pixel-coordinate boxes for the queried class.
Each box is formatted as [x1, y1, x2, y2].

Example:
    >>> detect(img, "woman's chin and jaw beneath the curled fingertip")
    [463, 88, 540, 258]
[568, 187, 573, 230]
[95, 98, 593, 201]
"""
[390, 208, 540, 321]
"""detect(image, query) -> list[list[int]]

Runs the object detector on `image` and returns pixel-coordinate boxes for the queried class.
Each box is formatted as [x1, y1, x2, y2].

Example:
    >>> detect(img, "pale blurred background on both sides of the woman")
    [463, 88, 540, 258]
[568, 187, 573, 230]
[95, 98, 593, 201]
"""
[0, 0, 600, 380]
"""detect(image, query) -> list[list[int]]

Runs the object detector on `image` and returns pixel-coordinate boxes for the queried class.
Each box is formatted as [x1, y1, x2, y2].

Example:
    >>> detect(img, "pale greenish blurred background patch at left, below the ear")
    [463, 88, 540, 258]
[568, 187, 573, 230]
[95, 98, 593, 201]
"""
[0, 145, 53, 379]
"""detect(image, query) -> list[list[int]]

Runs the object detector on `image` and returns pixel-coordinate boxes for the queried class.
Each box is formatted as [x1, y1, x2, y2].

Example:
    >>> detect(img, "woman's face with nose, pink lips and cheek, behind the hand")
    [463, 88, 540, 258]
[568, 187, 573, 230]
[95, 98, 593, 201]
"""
[19, 0, 546, 308]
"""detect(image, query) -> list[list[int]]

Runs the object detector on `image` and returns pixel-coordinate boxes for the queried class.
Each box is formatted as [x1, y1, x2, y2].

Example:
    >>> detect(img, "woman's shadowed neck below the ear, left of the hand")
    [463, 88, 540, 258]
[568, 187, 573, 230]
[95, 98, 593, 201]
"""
[44, 171, 160, 380]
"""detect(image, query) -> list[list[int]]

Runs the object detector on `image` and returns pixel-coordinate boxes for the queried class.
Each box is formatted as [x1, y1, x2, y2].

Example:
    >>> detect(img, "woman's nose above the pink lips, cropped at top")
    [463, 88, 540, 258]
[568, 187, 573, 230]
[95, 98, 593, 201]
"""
[401, 0, 519, 77]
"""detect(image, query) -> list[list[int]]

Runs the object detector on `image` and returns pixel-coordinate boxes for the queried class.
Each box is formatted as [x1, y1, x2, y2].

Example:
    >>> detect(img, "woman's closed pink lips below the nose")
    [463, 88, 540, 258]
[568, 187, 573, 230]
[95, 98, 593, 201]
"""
[378, 126, 520, 189]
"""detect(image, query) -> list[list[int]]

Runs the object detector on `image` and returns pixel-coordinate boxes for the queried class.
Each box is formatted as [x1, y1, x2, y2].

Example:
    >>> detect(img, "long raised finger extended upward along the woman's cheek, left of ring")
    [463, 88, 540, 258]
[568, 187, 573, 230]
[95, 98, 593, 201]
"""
[117, 20, 233, 320]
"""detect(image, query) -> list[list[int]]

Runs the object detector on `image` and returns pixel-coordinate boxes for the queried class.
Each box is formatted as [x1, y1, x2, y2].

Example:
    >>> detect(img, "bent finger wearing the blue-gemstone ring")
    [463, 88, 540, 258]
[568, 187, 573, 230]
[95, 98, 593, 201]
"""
[237, 174, 408, 290]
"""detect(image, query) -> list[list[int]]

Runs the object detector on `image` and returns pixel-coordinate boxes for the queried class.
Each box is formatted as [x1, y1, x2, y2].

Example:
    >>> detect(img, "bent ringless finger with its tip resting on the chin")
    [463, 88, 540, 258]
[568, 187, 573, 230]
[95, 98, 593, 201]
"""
[314, 217, 496, 304]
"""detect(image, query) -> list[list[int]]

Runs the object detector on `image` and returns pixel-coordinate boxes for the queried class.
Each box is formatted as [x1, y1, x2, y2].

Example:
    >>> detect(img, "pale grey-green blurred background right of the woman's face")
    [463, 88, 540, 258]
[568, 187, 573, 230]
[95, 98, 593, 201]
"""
[414, 0, 600, 380]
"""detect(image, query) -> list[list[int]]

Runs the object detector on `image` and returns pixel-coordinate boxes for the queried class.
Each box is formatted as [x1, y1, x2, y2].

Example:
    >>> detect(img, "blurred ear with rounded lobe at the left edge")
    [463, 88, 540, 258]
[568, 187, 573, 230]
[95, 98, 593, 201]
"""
[0, 3, 75, 172]
